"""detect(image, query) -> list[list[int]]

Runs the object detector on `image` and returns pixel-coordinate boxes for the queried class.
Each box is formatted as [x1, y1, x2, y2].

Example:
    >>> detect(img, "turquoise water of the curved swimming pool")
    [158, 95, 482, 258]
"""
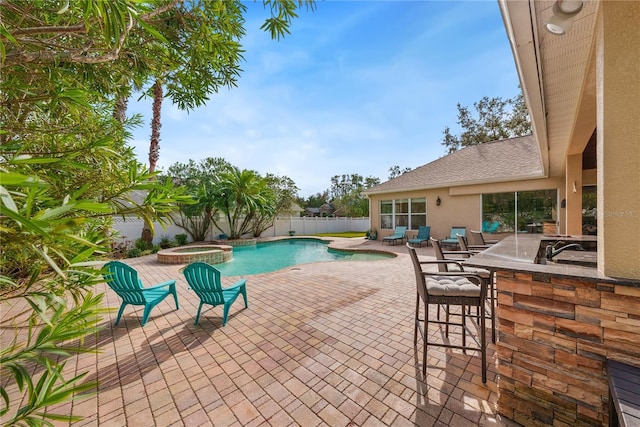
[214, 239, 394, 276]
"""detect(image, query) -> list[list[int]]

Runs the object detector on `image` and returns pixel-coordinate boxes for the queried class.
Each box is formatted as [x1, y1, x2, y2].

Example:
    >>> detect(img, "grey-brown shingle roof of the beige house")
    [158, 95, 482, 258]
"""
[365, 135, 544, 194]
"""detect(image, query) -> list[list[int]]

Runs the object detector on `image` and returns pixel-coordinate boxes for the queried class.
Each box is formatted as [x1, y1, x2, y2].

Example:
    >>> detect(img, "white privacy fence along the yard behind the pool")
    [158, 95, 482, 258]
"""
[113, 217, 369, 243]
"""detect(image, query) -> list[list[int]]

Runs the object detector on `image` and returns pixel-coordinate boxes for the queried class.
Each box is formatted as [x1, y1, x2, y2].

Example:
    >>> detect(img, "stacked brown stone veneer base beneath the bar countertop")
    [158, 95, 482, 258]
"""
[497, 271, 640, 426]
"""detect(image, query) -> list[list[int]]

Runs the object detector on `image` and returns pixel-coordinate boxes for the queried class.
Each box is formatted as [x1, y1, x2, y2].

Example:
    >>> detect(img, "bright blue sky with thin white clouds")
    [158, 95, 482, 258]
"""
[129, 0, 519, 198]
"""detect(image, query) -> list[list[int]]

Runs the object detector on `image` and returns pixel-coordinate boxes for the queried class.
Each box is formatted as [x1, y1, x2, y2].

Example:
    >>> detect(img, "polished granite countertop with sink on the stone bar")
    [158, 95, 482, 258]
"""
[464, 233, 640, 287]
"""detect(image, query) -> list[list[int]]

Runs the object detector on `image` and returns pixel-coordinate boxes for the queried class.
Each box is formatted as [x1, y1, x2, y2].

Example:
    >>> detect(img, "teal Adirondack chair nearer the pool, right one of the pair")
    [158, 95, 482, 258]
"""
[183, 262, 249, 326]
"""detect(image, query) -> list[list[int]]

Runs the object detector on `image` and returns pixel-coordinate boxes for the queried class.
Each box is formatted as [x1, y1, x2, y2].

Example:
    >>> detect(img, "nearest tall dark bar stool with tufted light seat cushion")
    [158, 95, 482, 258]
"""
[406, 244, 487, 383]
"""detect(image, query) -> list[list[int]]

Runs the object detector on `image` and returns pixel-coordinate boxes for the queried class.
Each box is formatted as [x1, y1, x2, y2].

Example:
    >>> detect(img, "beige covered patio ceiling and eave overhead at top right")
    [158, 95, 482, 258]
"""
[498, 0, 599, 177]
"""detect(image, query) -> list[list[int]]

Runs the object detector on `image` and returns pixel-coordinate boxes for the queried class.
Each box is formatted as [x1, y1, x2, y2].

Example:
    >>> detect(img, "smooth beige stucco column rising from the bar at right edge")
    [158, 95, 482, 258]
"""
[596, 1, 640, 279]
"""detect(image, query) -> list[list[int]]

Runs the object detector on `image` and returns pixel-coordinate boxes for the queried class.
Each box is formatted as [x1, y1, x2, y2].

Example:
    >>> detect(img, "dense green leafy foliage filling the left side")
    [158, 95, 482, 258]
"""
[0, 0, 314, 425]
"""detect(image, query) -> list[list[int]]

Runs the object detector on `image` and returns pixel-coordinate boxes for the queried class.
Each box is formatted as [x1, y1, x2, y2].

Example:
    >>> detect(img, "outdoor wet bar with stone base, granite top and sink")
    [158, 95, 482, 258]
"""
[467, 234, 640, 426]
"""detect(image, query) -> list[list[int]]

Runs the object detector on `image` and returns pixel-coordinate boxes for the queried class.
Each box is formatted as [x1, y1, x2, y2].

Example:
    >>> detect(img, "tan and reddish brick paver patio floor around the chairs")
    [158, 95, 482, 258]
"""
[1, 239, 511, 427]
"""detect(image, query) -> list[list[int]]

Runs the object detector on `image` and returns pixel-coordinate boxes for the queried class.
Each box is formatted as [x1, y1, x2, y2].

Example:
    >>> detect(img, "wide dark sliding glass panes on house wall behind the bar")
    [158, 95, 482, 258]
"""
[482, 189, 558, 233]
